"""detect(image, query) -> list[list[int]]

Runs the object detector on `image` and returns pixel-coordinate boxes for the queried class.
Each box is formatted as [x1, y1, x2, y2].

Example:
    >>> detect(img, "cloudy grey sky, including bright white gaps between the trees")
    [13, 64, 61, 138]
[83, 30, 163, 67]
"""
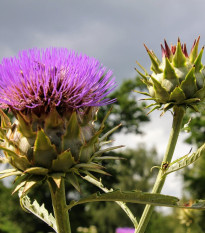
[0, 0, 205, 198]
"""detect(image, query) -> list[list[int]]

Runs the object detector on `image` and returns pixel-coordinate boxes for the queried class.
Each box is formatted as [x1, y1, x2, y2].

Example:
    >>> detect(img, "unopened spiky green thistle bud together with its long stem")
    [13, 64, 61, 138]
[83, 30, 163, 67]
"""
[136, 38, 205, 233]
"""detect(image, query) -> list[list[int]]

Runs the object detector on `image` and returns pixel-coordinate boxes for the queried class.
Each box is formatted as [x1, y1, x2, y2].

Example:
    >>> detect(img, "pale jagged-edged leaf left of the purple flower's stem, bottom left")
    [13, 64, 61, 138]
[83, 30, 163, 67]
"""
[19, 193, 57, 232]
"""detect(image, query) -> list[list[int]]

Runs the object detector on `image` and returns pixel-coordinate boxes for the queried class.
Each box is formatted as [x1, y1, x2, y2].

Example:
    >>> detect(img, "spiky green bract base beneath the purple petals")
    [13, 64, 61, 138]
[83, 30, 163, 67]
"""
[0, 107, 119, 194]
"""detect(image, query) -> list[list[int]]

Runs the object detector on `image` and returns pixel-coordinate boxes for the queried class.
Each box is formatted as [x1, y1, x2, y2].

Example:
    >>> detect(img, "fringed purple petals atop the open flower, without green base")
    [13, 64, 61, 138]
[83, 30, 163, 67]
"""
[0, 48, 116, 111]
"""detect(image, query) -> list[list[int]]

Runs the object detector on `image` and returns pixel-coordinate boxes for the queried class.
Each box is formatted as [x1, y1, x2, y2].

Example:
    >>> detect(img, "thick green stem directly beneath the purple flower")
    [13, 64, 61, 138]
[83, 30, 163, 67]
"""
[48, 178, 71, 233]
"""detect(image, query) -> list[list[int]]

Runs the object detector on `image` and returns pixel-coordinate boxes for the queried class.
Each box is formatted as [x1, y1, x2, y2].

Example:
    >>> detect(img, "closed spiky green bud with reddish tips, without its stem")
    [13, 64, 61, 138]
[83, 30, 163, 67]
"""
[136, 37, 205, 112]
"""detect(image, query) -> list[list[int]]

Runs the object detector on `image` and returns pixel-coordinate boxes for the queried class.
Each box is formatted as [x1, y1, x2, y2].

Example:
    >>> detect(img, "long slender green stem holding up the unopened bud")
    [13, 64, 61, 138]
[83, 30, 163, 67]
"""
[136, 106, 185, 233]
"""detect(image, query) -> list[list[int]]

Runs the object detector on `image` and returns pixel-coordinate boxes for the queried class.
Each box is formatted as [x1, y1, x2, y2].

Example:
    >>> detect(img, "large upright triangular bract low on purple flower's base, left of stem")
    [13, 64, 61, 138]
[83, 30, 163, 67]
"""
[33, 129, 57, 168]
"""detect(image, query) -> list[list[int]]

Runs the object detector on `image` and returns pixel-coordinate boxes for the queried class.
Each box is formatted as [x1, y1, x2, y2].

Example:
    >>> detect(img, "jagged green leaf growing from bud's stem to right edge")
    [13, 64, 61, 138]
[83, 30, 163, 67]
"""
[164, 144, 205, 175]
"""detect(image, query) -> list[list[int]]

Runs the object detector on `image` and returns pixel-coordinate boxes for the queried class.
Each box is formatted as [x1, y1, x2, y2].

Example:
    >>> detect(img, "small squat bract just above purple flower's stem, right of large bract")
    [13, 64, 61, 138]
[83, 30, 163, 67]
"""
[52, 150, 76, 172]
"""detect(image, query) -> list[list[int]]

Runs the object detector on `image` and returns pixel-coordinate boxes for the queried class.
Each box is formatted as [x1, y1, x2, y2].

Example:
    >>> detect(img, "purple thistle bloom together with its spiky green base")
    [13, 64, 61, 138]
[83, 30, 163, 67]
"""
[0, 48, 118, 193]
